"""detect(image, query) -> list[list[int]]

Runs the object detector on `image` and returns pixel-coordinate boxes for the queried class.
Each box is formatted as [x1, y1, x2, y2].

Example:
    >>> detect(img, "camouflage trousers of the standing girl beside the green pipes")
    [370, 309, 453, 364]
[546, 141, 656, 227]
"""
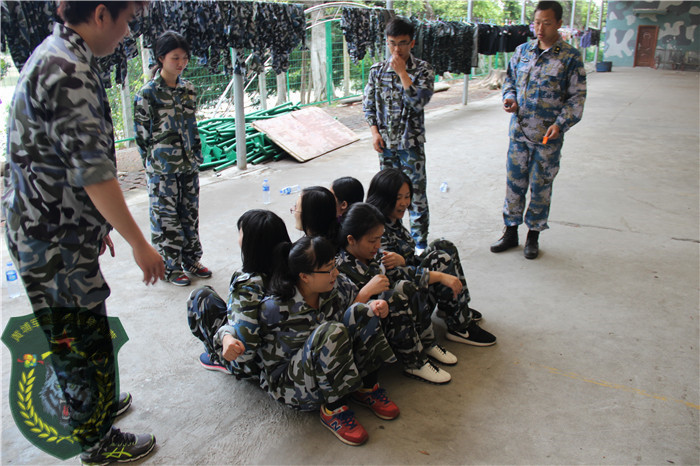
[148, 172, 202, 271]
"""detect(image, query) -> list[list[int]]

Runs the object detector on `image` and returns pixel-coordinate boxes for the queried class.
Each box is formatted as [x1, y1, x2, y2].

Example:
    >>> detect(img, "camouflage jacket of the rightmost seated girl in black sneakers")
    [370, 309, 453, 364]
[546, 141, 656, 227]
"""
[382, 220, 430, 289]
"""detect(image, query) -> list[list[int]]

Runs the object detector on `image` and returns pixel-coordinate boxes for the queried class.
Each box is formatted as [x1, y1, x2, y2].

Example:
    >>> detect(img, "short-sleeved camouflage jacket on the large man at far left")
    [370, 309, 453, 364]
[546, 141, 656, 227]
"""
[2, 24, 117, 245]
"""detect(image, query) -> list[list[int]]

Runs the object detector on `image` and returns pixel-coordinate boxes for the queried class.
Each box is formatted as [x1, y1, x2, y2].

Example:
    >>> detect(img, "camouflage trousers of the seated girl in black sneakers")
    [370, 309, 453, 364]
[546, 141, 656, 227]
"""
[419, 238, 472, 332]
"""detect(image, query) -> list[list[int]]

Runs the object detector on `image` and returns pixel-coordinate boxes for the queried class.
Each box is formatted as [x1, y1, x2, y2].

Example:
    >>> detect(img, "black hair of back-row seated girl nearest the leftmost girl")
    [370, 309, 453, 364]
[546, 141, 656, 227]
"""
[301, 186, 338, 244]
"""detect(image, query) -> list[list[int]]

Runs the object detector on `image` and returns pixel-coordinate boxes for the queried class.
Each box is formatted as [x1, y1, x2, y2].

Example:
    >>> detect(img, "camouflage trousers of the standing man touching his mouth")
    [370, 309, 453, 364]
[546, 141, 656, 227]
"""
[379, 144, 430, 249]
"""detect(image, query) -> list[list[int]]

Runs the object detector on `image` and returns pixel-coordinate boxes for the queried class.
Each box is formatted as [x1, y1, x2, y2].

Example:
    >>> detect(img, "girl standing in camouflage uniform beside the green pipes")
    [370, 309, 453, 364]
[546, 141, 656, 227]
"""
[134, 31, 212, 286]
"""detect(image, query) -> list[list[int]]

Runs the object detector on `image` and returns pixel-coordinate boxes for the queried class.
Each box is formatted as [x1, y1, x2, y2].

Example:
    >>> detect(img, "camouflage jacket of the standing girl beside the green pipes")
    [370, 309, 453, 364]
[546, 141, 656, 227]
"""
[134, 74, 202, 175]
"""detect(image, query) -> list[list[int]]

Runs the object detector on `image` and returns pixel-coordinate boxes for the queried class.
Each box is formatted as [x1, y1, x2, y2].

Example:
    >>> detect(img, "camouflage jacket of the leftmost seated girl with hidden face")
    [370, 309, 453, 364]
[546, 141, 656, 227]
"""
[214, 271, 268, 377]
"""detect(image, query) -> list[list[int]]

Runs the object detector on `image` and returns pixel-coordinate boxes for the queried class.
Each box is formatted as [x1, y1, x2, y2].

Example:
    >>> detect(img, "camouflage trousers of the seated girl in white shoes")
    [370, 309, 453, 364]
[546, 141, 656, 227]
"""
[377, 280, 427, 369]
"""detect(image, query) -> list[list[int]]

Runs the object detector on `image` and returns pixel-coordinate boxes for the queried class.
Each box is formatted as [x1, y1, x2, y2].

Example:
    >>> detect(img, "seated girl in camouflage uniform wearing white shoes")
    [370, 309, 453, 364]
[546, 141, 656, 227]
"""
[336, 203, 457, 384]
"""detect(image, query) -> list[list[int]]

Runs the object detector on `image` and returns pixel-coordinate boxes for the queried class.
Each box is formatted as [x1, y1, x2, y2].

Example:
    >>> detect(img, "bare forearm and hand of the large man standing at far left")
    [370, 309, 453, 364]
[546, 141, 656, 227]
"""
[84, 178, 165, 284]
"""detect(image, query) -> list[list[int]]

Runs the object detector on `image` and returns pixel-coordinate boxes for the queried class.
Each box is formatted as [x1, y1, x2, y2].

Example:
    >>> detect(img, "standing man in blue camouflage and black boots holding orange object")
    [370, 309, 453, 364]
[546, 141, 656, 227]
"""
[491, 2, 586, 259]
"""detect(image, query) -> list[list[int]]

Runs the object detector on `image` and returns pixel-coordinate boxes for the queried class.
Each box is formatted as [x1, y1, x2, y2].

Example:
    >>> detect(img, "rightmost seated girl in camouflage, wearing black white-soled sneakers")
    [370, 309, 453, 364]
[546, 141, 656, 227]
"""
[367, 168, 496, 346]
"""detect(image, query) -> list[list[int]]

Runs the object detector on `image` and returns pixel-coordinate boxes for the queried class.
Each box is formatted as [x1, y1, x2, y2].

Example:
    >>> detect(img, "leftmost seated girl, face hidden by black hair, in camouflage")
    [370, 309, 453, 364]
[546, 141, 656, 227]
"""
[187, 209, 290, 381]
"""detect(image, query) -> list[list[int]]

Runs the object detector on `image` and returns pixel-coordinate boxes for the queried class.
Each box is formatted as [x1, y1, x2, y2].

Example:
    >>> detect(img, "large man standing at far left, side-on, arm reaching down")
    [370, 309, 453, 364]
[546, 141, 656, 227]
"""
[2, 1, 163, 464]
